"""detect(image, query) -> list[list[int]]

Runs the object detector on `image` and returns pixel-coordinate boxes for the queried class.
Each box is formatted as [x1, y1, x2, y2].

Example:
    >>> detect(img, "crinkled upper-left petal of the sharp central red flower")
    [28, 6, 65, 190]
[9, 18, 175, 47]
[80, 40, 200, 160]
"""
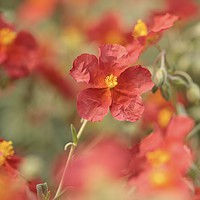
[70, 54, 98, 83]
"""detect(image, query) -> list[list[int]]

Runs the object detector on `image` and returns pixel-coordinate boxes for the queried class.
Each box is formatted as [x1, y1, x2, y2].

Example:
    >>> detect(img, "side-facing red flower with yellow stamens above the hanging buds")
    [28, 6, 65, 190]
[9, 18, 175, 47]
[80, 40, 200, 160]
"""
[132, 13, 178, 48]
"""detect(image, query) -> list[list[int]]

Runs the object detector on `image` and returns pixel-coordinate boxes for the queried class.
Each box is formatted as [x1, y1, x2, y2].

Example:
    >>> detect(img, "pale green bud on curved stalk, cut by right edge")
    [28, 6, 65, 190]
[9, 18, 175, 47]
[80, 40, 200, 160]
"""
[186, 83, 200, 103]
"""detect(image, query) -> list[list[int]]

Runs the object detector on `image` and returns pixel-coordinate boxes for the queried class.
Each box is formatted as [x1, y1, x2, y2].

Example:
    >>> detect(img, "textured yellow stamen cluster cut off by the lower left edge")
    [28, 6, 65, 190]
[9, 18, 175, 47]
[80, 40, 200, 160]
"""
[0, 141, 14, 166]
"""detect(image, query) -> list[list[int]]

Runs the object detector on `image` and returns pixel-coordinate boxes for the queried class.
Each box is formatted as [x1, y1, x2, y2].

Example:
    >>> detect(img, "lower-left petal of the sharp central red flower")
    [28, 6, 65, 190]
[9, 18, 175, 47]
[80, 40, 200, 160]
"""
[77, 88, 111, 122]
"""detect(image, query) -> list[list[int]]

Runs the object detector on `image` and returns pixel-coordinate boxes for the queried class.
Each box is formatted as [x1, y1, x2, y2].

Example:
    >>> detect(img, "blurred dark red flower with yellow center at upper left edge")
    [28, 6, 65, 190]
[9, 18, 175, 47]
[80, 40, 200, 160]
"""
[0, 16, 39, 79]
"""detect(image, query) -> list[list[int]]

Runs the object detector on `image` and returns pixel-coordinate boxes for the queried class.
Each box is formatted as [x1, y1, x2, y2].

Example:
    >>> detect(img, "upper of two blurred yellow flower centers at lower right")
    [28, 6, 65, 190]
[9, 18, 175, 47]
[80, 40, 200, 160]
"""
[146, 149, 170, 166]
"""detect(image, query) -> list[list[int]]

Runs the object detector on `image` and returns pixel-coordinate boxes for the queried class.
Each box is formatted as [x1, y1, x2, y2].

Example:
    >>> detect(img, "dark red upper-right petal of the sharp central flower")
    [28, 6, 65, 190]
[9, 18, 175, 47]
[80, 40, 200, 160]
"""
[115, 66, 154, 96]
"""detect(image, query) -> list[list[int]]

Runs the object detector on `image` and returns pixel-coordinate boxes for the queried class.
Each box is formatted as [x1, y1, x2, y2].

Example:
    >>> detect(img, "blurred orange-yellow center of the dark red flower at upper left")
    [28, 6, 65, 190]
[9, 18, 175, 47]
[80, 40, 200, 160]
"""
[0, 28, 16, 45]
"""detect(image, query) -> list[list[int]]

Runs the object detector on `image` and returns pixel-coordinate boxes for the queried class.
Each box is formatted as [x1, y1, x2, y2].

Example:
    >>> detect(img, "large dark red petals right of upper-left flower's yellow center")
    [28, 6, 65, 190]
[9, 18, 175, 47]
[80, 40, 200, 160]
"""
[3, 31, 39, 79]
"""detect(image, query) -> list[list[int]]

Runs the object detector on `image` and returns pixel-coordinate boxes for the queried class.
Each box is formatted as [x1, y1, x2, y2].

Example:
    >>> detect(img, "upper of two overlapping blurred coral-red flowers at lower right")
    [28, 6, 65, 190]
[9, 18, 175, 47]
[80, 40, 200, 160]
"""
[140, 116, 194, 174]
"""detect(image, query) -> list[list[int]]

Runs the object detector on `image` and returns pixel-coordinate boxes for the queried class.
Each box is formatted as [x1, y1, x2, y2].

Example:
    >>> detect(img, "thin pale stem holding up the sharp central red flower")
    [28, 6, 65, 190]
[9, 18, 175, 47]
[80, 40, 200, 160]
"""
[53, 120, 88, 200]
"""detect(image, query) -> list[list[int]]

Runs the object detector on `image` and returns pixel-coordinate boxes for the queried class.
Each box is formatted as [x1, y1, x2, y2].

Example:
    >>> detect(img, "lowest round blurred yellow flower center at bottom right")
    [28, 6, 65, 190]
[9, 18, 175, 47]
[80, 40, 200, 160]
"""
[149, 169, 171, 187]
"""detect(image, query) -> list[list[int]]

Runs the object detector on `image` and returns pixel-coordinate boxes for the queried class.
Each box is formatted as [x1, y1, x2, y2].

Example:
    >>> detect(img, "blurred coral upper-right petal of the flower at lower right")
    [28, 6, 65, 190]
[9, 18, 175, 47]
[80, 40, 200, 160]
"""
[166, 116, 194, 143]
